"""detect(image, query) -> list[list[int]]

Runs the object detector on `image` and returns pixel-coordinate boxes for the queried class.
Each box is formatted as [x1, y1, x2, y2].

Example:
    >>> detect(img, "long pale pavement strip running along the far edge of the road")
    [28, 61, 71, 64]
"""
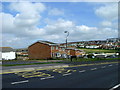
[0, 60, 118, 74]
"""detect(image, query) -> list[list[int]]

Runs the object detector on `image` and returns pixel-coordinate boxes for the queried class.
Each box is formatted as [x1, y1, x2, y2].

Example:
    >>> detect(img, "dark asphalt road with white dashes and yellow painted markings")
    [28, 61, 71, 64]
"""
[2, 63, 120, 90]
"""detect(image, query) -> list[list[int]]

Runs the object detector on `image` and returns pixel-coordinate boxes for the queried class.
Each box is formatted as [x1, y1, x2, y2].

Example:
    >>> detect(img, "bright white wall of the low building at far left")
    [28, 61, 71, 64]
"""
[2, 52, 16, 60]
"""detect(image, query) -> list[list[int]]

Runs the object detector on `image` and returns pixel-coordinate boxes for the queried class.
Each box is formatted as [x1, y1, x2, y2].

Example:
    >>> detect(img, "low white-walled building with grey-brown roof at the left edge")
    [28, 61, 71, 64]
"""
[0, 47, 16, 60]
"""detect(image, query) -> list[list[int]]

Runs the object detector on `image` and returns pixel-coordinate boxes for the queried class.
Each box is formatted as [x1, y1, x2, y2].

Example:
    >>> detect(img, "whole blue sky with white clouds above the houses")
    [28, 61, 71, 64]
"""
[0, 2, 118, 48]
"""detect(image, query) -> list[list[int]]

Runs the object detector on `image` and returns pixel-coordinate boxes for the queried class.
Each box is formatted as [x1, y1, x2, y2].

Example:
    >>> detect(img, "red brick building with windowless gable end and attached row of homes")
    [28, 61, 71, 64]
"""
[28, 41, 85, 59]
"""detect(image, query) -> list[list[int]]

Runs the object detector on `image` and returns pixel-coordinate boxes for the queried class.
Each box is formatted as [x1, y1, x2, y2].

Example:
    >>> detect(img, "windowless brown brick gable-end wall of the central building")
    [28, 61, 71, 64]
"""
[28, 42, 51, 59]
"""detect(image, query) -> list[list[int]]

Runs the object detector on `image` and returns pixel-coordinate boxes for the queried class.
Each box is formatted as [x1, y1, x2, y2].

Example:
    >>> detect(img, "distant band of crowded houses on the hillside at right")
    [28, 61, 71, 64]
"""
[60, 38, 120, 49]
